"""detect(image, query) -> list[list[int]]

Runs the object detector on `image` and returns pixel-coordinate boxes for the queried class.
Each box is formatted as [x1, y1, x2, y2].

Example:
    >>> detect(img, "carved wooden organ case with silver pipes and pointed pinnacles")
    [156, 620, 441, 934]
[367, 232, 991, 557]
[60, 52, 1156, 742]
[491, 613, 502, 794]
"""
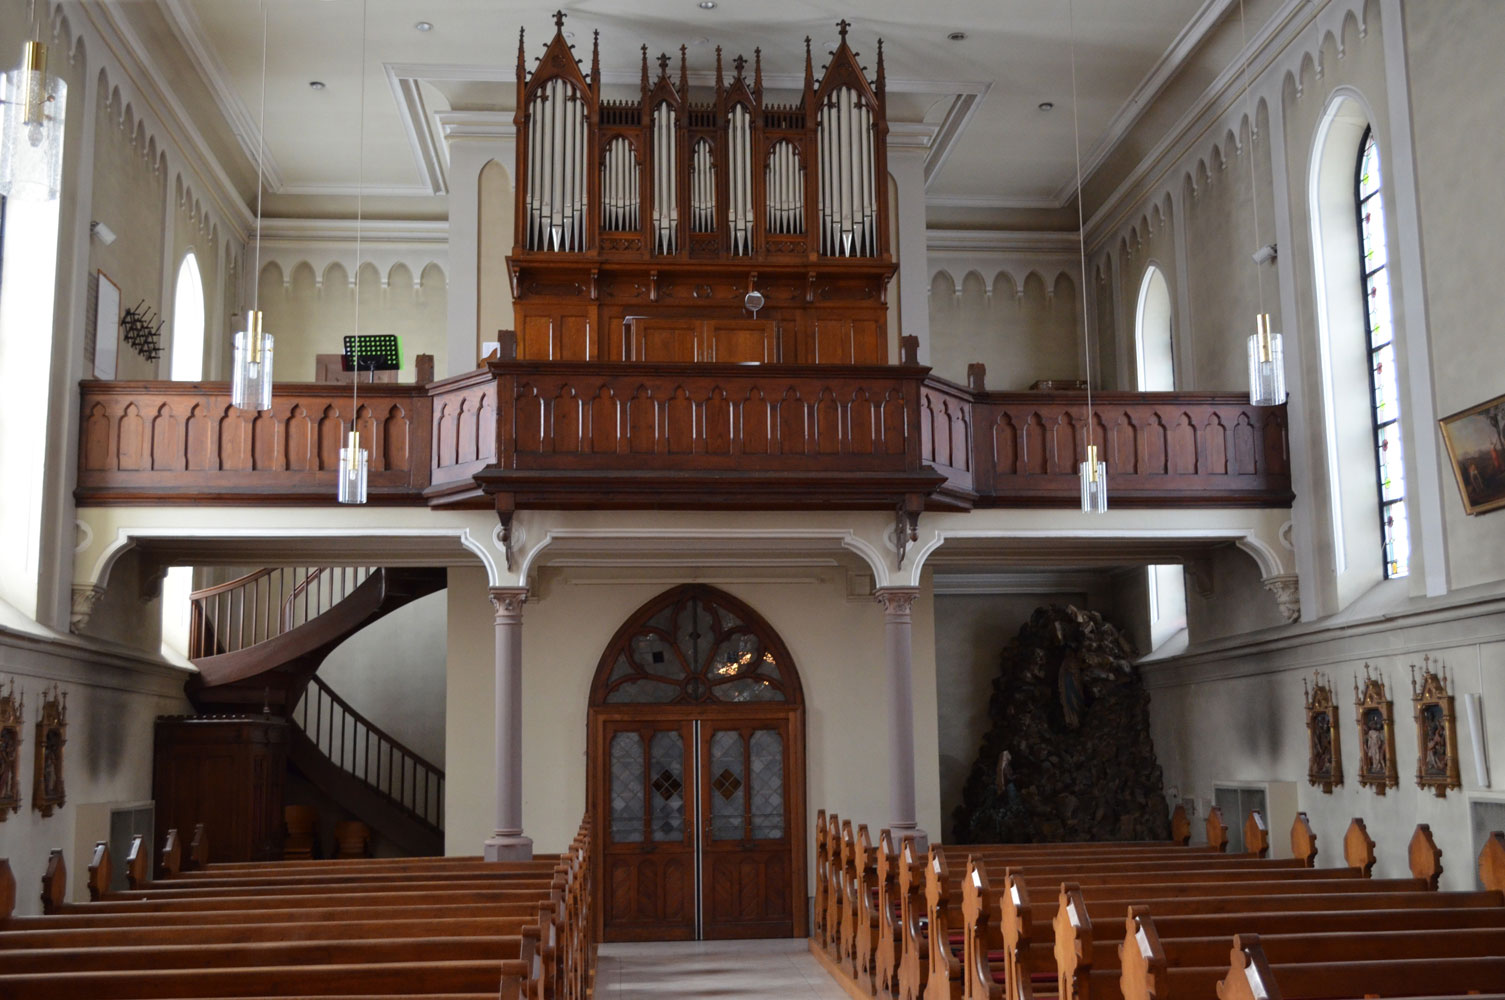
[507, 14, 894, 364]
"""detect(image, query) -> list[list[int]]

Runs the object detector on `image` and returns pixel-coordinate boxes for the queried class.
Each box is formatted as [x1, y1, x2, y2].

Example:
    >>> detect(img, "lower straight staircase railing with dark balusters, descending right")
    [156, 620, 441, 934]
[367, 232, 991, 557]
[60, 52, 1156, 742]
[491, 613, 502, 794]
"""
[289, 675, 444, 831]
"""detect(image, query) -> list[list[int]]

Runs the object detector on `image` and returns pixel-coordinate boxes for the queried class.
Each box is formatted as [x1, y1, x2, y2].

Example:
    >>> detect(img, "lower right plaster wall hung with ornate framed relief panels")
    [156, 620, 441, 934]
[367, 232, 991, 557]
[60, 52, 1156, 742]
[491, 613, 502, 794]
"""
[1142, 599, 1505, 889]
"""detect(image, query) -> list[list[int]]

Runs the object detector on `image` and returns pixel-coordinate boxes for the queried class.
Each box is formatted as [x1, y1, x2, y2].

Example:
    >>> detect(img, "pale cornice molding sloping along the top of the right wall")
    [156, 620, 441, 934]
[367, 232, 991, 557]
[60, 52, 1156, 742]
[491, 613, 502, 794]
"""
[1087, 0, 1327, 245]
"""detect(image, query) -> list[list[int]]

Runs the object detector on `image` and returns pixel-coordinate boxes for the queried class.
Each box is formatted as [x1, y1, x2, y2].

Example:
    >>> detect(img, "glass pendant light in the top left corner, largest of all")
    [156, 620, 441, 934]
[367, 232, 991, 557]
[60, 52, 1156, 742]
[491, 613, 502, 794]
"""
[0, 0, 68, 202]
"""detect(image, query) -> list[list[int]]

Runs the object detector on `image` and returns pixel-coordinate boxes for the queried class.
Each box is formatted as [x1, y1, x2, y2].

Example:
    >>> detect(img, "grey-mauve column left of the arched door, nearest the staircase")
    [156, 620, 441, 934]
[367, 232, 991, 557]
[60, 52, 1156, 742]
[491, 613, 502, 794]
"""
[485, 587, 533, 861]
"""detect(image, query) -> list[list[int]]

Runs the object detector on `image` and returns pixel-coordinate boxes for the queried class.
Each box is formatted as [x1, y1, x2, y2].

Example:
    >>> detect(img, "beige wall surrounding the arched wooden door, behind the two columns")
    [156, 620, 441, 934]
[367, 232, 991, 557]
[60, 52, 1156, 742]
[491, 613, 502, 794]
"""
[445, 569, 942, 885]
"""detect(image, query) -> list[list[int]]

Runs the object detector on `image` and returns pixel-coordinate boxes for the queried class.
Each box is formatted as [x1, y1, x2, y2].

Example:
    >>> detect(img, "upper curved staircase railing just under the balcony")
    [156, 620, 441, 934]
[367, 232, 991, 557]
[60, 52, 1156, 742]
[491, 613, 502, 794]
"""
[188, 566, 378, 660]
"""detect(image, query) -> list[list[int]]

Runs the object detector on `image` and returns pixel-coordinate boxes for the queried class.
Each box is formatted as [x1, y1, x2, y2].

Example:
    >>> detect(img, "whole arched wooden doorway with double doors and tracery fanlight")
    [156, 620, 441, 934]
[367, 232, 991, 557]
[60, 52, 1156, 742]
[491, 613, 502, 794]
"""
[588, 584, 805, 941]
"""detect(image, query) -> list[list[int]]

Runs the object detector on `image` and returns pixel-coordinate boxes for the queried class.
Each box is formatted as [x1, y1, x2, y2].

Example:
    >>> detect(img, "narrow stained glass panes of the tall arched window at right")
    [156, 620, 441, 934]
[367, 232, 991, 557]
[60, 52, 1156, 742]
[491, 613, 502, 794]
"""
[1356, 128, 1410, 578]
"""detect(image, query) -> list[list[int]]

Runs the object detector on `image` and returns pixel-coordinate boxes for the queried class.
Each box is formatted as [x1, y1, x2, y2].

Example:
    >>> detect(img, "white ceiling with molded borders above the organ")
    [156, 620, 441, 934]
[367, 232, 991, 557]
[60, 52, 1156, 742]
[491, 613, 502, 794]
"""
[155, 0, 1230, 215]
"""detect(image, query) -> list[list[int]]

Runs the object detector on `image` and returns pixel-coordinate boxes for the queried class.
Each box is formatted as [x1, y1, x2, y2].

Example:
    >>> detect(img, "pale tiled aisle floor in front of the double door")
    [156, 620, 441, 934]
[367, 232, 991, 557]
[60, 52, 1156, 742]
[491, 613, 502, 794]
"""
[596, 938, 847, 1000]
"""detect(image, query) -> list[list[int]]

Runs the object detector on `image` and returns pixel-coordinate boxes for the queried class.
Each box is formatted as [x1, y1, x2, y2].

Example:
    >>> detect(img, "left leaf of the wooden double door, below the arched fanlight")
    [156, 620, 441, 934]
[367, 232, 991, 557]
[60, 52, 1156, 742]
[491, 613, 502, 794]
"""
[600, 720, 697, 941]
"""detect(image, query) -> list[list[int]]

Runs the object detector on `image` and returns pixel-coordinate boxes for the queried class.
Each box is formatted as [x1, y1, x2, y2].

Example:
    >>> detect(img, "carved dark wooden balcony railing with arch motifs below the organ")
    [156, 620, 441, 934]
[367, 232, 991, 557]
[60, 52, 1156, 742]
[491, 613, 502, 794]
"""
[77, 361, 1291, 512]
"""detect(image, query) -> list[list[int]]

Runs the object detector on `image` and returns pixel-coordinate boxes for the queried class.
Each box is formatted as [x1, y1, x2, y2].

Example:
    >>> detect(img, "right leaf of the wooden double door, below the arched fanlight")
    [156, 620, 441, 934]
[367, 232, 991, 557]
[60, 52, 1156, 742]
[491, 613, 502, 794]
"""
[698, 720, 795, 940]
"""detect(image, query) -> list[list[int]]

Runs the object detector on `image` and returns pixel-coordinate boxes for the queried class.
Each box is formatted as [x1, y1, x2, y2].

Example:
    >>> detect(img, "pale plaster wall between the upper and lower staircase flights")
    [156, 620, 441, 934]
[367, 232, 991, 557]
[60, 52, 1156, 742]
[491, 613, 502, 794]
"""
[319, 590, 448, 768]
